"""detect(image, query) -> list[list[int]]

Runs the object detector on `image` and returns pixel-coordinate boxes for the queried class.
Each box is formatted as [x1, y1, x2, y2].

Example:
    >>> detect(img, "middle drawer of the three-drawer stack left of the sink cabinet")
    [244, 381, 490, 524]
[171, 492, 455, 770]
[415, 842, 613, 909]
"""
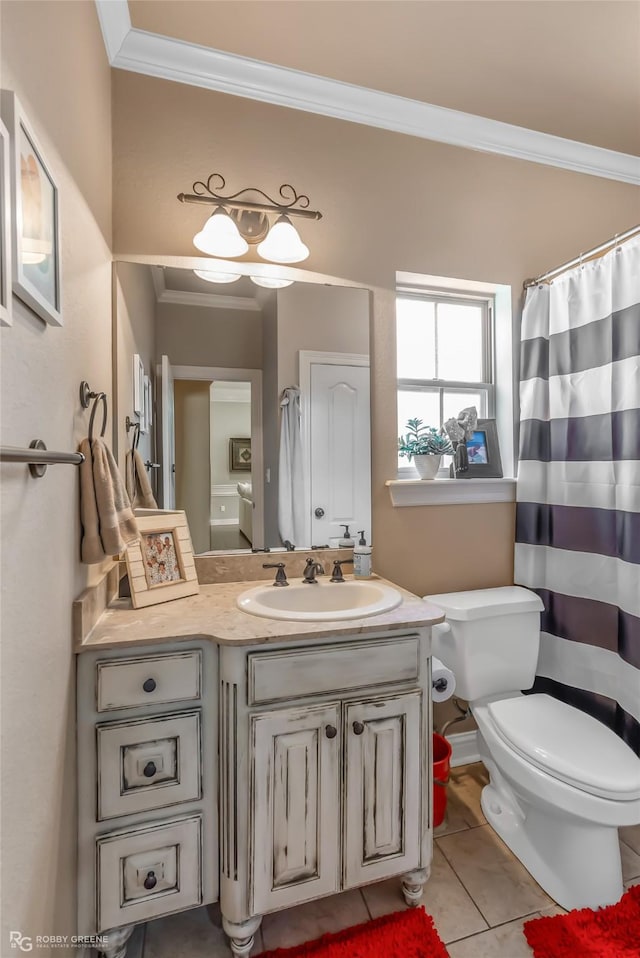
[96, 710, 202, 821]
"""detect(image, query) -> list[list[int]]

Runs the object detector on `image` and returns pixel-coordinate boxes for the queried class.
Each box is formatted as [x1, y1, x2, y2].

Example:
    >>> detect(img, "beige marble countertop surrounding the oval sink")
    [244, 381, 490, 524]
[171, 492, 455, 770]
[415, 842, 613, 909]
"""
[76, 579, 444, 652]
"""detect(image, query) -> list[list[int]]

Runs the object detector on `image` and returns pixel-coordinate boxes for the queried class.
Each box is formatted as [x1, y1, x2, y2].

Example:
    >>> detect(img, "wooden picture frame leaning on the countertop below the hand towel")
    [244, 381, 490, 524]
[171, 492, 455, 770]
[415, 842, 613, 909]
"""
[125, 509, 200, 609]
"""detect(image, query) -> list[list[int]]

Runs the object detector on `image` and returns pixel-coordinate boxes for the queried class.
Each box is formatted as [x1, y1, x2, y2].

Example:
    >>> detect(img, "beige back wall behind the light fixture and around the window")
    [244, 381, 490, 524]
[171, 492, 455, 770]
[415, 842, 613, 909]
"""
[114, 72, 640, 593]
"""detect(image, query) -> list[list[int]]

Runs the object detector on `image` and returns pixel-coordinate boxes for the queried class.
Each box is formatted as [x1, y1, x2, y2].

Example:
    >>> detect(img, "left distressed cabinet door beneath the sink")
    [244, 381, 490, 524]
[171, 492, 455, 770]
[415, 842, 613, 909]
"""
[251, 704, 341, 915]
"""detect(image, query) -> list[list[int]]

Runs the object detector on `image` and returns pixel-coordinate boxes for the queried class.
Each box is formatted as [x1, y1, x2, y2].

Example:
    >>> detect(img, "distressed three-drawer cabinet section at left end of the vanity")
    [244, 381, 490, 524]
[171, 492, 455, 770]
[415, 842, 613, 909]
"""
[78, 641, 218, 958]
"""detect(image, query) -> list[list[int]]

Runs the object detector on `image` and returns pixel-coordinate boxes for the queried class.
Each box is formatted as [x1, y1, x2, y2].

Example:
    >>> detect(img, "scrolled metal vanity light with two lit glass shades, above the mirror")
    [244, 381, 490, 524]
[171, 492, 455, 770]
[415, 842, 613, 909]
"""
[178, 173, 322, 264]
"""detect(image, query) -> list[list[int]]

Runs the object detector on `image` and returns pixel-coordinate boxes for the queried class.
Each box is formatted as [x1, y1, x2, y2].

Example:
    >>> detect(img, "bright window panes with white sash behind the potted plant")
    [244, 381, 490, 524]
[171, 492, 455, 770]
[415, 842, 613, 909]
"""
[396, 290, 495, 476]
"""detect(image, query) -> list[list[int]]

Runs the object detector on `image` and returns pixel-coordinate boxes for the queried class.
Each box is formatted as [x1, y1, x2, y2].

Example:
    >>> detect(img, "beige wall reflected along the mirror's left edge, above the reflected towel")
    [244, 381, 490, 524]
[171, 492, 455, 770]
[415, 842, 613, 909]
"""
[113, 263, 156, 470]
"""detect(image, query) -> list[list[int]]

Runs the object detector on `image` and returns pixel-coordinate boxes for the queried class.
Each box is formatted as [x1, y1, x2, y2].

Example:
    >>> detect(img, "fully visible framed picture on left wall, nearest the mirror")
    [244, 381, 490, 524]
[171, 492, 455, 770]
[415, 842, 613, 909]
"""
[2, 90, 62, 326]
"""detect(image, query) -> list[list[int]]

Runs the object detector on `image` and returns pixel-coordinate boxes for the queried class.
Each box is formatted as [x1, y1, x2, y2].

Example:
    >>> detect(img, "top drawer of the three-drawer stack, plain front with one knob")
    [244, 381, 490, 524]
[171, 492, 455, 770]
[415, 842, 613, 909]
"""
[96, 649, 202, 712]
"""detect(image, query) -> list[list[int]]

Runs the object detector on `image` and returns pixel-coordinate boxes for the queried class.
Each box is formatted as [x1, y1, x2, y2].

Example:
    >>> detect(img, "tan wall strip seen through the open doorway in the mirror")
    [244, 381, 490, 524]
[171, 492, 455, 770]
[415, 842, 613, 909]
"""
[173, 379, 211, 553]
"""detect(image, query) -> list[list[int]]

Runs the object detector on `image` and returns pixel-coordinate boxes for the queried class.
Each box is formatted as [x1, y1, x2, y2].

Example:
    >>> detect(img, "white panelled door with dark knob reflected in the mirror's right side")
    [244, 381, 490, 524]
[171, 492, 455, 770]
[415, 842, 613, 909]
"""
[309, 363, 371, 545]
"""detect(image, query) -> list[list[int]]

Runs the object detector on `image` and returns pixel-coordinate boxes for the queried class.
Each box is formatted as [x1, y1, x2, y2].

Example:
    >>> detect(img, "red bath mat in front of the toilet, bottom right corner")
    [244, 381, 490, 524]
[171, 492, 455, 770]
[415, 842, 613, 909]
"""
[524, 884, 640, 958]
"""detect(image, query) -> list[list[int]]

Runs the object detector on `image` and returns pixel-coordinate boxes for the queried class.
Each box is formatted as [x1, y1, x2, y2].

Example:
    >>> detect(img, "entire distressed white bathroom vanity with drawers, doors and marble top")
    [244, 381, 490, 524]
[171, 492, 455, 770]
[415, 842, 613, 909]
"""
[78, 582, 442, 958]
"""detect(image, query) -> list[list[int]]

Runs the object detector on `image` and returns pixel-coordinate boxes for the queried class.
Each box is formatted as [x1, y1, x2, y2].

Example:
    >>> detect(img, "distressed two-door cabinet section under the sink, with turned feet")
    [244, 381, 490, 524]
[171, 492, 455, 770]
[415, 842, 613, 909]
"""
[220, 629, 431, 956]
